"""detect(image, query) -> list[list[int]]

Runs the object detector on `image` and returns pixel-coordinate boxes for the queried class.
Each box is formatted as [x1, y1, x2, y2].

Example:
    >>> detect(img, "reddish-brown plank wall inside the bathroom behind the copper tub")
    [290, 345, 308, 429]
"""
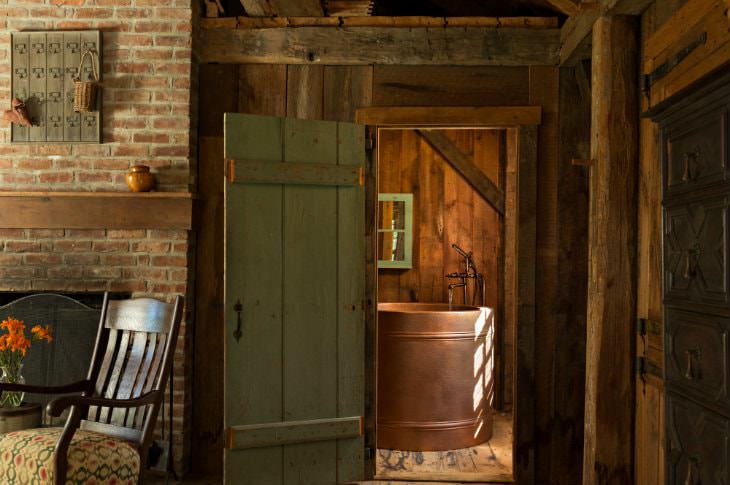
[378, 130, 503, 308]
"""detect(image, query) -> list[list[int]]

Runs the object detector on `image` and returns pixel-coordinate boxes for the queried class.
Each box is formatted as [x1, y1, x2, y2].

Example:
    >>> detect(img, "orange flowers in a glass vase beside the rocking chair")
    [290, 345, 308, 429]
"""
[0, 317, 53, 407]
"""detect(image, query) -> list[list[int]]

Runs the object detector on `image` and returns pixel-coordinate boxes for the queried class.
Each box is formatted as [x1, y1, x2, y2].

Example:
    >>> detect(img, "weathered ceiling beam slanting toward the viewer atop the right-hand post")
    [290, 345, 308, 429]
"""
[560, 0, 654, 66]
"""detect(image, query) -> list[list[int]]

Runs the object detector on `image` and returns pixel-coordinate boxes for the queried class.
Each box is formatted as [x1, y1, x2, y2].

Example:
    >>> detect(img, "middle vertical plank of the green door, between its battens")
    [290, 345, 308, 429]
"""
[283, 119, 337, 484]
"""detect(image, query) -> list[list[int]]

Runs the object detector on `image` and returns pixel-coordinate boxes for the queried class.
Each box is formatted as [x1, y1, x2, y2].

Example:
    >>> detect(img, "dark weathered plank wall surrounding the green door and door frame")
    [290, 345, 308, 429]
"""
[192, 65, 587, 485]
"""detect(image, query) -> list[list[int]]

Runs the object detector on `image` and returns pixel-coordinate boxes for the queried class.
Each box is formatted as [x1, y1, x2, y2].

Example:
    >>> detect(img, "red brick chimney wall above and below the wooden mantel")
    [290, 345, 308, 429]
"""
[0, 0, 195, 470]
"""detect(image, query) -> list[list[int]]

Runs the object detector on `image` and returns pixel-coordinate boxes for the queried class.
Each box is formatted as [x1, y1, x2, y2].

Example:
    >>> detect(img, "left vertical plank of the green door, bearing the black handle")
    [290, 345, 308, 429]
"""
[224, 114, 284, 485]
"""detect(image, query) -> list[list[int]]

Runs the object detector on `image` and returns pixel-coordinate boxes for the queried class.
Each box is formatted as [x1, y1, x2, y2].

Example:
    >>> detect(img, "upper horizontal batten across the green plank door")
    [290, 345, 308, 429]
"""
[229, 160, 364, 186]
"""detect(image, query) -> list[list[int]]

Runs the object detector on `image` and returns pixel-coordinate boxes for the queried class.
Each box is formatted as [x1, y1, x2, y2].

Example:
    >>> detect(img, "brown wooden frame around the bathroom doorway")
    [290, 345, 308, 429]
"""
[355, 106, 542, 484]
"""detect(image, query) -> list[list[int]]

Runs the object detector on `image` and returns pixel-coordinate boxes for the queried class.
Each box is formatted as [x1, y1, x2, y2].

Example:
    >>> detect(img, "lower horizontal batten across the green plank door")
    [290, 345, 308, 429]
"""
[226, 416, 363, 450]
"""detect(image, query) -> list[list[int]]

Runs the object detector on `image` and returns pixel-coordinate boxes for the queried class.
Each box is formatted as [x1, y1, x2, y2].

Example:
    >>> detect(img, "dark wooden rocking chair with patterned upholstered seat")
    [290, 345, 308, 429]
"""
[0, 295, 183, 485]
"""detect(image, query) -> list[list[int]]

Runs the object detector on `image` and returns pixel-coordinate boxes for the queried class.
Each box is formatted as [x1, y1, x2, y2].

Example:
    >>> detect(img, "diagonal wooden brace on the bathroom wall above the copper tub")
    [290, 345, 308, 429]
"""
[416, 130, 504, 216]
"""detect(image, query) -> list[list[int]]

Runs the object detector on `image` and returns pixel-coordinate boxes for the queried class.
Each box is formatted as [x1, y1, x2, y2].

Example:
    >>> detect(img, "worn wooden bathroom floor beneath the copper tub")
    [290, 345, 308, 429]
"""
[375, 413, 512, 482]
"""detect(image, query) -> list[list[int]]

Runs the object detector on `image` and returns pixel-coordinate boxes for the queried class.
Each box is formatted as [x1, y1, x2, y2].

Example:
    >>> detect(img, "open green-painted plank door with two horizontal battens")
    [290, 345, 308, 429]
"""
[225, 114, 365, 485]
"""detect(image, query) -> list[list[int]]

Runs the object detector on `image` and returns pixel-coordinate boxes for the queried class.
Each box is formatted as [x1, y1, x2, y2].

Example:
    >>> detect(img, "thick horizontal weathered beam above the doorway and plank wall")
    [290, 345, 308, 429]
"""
[200, 27, 560, 66]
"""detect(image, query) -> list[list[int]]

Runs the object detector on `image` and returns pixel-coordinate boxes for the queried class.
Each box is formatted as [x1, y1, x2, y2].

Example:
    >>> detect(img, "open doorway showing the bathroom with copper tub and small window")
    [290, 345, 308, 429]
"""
[372, 126, 518, 482]
